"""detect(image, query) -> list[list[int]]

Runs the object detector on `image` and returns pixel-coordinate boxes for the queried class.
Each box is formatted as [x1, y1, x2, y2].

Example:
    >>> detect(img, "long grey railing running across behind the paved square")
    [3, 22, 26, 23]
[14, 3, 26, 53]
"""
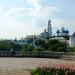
[0, 51, 75, 58]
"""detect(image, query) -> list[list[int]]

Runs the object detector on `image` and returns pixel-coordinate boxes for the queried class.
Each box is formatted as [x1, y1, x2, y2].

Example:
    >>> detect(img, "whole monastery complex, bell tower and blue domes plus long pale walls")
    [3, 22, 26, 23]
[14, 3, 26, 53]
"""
[11, 20, 75, 46]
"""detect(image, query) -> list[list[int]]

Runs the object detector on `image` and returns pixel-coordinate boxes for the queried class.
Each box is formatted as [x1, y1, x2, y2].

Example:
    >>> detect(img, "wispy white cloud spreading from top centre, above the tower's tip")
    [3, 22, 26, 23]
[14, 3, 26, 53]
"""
[6, 0, 60, 21]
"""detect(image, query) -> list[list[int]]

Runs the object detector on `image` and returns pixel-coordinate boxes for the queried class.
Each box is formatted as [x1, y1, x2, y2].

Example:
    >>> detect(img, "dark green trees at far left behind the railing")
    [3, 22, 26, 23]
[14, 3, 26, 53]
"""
[0, 40, 21, 51]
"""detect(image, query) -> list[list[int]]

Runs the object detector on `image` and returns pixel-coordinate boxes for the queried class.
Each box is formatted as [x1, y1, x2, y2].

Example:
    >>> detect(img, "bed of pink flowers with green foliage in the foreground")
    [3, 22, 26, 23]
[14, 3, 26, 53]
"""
[32, 64, 75, 75]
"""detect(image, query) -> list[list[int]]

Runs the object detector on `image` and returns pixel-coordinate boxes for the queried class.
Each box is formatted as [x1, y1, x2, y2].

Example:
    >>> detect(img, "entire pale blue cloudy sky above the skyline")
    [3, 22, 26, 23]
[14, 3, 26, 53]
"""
[0, 0, 75, 39]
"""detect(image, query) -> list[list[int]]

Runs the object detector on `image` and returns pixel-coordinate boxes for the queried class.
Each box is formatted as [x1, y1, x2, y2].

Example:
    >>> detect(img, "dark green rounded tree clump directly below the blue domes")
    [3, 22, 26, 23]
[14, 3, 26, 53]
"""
[48, 40, 66, 52]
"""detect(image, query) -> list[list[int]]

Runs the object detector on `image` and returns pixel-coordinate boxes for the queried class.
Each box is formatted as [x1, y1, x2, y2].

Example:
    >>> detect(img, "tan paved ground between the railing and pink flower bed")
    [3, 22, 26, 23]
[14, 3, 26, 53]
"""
[0, 57, 75, 75]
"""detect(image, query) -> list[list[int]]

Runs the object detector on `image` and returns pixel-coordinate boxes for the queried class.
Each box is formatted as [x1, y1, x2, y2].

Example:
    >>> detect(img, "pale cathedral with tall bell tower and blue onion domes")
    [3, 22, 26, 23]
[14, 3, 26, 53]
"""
[41, 20, 69, 38]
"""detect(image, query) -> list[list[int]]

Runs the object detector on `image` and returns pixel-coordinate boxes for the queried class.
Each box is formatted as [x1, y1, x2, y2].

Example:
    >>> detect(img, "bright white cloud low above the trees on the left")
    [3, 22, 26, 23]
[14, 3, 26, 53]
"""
[0, 14, 39, 39]
